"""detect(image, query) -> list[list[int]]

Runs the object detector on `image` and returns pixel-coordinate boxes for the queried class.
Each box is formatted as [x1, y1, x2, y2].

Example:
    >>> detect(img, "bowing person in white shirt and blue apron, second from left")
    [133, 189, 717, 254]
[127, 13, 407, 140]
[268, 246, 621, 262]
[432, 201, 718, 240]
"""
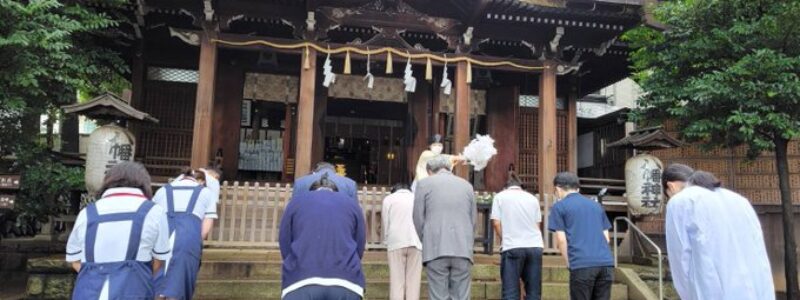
[153, 169, 217, 299]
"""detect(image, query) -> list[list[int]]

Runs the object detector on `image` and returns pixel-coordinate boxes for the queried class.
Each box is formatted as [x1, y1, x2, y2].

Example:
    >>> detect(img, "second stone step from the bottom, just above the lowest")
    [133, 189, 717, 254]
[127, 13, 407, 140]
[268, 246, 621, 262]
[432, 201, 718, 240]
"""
[199, 260, 569, 282]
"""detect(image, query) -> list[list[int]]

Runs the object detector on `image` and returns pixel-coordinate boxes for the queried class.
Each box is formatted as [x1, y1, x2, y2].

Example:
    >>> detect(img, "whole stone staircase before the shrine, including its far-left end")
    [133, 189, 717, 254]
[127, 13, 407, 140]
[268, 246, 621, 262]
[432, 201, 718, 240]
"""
[26, 249, 657, 300]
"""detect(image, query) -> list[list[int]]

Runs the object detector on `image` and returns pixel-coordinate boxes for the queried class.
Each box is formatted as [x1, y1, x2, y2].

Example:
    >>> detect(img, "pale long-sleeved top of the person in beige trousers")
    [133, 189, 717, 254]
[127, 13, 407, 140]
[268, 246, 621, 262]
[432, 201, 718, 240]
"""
[381, 189, 422, 251]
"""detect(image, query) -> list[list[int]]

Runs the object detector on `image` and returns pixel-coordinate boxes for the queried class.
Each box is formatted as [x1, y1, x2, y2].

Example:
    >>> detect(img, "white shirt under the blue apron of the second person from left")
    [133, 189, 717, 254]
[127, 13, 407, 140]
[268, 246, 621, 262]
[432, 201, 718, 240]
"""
[153, 178, 217, 220]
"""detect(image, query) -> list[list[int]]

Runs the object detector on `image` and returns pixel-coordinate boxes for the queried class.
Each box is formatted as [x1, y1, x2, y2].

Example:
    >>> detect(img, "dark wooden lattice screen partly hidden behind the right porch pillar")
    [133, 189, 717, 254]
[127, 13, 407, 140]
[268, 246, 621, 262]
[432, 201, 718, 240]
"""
[517, 107, 568, 192]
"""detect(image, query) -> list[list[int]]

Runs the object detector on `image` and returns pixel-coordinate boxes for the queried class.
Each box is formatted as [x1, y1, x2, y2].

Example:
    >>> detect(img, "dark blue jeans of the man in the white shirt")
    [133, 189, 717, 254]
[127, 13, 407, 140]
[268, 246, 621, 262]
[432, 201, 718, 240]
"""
[500, 248, 542, 300]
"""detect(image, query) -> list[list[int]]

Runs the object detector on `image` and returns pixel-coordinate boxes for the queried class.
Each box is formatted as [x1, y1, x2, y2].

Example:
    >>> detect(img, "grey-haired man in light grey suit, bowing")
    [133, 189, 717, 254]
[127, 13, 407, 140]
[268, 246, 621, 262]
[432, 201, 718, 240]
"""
[414, 155, 478, 300]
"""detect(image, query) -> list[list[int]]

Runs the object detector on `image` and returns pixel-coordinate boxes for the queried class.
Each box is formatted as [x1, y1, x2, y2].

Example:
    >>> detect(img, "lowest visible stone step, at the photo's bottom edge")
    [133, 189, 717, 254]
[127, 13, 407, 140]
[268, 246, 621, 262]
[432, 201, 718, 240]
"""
[194, 280, 628, 300]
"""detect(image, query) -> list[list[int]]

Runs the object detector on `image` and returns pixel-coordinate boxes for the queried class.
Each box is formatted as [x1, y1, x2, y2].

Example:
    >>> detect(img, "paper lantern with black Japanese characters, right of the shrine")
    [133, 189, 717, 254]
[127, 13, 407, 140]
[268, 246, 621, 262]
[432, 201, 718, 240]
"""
[625, 154, 664, 216]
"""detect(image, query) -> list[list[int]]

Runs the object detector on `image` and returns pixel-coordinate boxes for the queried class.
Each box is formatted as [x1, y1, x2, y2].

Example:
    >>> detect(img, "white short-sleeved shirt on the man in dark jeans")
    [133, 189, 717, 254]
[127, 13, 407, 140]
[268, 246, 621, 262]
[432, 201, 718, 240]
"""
[491, 186, 544, 251]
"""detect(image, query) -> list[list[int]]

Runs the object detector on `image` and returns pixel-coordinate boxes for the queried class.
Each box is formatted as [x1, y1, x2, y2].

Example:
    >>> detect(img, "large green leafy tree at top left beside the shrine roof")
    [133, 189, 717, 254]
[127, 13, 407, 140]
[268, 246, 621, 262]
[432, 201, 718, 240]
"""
[0, 0, 127, 154]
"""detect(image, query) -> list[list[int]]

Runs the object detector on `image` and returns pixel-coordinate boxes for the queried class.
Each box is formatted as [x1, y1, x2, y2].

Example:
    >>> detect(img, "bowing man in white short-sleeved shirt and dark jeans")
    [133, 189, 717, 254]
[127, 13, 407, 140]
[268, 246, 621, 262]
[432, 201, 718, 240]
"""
[491, 174, 544, 300]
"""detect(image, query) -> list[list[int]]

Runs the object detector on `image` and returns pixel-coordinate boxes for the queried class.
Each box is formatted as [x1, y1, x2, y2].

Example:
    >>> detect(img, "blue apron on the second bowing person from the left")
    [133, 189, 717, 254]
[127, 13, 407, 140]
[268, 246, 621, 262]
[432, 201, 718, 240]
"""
[156, 184, 203, 299]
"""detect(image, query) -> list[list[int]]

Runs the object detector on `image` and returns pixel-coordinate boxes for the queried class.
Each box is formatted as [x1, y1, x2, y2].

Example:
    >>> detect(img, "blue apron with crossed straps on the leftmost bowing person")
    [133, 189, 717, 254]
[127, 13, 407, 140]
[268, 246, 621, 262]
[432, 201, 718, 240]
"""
[72, 201, 155, 300]
